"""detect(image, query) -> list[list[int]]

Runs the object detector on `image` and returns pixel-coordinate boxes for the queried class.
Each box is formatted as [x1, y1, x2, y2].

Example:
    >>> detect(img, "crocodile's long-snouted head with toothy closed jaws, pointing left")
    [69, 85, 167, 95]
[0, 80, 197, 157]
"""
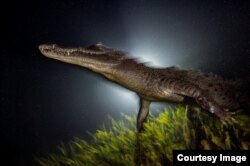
[39, 43, 124, 73]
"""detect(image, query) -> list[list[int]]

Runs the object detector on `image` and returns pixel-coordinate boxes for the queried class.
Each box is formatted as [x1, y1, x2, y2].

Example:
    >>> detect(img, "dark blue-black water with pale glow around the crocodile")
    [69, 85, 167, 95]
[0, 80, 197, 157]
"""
[0, 0, 250, 165]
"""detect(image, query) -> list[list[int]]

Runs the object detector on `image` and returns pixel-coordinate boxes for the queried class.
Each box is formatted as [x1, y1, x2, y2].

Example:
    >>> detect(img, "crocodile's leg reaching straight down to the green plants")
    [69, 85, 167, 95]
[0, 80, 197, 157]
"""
[137, 98, 151, 133]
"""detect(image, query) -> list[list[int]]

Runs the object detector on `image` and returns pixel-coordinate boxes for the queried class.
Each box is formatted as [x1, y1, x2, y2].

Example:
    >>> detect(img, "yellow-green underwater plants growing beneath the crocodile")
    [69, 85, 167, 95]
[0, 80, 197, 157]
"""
[37, 106, 250, 166]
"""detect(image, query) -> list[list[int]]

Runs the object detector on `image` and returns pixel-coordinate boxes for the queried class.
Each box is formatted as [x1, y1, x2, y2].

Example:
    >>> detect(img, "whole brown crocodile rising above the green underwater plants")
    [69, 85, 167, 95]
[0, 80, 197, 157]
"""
[39, 42, 249, 132]
